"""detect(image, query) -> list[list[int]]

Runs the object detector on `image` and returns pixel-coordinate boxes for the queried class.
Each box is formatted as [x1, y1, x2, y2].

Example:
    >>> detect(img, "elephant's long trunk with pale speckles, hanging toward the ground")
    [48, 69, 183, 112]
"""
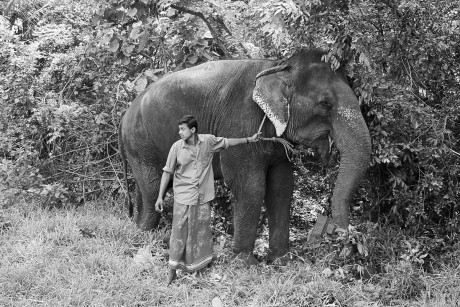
[331, 100, 371, 228]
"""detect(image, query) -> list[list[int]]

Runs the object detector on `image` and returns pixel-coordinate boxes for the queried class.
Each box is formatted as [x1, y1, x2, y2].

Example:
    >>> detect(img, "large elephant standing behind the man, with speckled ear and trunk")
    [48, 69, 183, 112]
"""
[119, 49, 371, 264]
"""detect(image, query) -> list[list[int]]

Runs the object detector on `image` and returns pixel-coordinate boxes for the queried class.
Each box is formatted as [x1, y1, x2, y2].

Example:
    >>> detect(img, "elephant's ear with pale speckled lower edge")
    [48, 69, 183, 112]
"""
[252, 65, 291, 136]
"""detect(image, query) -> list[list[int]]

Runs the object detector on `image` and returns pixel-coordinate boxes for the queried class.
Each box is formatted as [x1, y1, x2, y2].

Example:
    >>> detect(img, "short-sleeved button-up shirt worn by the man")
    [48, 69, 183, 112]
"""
[163, 134, 228, 205]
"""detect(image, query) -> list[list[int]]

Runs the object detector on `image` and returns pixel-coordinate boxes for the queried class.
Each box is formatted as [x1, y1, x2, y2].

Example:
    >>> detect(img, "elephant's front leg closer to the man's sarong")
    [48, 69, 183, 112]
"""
[228, 169, 265, 265]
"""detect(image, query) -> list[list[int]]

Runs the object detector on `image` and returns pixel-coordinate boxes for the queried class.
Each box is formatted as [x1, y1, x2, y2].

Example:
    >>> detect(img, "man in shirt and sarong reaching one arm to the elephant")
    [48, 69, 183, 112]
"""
[155, 115, 259, 285]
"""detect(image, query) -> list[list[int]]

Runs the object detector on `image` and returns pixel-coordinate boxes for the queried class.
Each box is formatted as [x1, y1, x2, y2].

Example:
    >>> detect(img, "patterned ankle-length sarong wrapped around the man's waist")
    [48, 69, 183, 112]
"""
[169, 202, 213, 272]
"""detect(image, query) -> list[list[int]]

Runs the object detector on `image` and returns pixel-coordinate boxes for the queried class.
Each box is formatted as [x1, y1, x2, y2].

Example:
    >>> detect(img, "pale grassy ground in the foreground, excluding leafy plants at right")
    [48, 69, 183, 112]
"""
[0, 201, 460, 307]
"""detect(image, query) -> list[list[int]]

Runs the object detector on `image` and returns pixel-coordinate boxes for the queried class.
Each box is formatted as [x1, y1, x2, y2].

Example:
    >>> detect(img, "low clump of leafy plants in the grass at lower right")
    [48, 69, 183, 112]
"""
[302, 222, 459, 304]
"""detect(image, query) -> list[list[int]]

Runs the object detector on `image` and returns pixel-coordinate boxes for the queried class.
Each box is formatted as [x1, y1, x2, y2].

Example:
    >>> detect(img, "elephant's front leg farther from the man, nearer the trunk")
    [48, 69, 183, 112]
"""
[265, 161, 294, 264]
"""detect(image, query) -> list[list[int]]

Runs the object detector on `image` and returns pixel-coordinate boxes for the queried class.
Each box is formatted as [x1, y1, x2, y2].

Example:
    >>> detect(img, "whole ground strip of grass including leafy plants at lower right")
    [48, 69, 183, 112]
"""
[0, 199, 460, 307]
